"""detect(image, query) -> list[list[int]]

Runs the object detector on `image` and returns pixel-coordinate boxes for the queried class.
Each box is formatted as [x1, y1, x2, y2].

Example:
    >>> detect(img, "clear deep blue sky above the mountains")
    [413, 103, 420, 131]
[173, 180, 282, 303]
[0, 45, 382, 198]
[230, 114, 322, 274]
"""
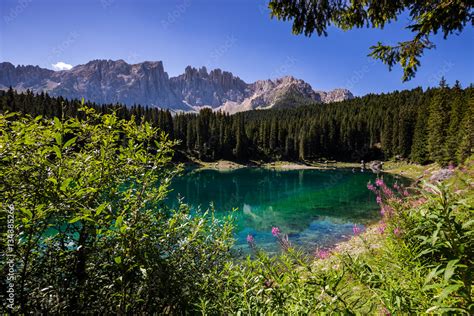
[0, 0, 474, 95]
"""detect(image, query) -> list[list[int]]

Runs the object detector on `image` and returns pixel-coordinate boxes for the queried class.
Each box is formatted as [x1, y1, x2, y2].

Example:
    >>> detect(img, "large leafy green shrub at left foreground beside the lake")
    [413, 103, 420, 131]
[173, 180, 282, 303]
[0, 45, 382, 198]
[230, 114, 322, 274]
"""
[0, 108, 232, 314]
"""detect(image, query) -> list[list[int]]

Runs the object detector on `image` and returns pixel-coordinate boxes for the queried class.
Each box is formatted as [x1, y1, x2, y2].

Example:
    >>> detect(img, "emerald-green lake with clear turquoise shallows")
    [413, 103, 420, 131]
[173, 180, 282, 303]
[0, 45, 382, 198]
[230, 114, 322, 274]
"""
[168, 168, 404, 252]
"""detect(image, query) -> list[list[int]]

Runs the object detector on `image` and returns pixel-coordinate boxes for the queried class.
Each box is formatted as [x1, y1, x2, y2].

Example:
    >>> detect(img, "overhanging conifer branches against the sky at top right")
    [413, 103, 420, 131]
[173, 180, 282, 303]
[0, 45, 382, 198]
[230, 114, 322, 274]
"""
[268, 0, 474, 81]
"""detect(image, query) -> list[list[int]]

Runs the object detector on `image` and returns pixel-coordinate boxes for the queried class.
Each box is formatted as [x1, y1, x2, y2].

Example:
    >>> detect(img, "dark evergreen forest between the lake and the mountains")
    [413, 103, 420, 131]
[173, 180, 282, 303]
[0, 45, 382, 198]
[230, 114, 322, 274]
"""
[0, 81, 474, 165]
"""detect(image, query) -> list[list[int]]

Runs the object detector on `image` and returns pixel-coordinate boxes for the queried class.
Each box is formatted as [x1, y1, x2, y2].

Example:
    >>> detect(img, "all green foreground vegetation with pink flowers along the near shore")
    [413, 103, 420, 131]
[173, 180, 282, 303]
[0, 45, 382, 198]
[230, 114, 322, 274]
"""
[0, 100, 474, 314]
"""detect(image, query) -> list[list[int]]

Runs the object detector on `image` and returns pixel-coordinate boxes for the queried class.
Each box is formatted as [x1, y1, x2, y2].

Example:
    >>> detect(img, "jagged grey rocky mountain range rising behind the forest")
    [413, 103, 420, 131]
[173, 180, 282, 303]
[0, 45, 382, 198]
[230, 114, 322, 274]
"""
[0, 60, 353, 113]
